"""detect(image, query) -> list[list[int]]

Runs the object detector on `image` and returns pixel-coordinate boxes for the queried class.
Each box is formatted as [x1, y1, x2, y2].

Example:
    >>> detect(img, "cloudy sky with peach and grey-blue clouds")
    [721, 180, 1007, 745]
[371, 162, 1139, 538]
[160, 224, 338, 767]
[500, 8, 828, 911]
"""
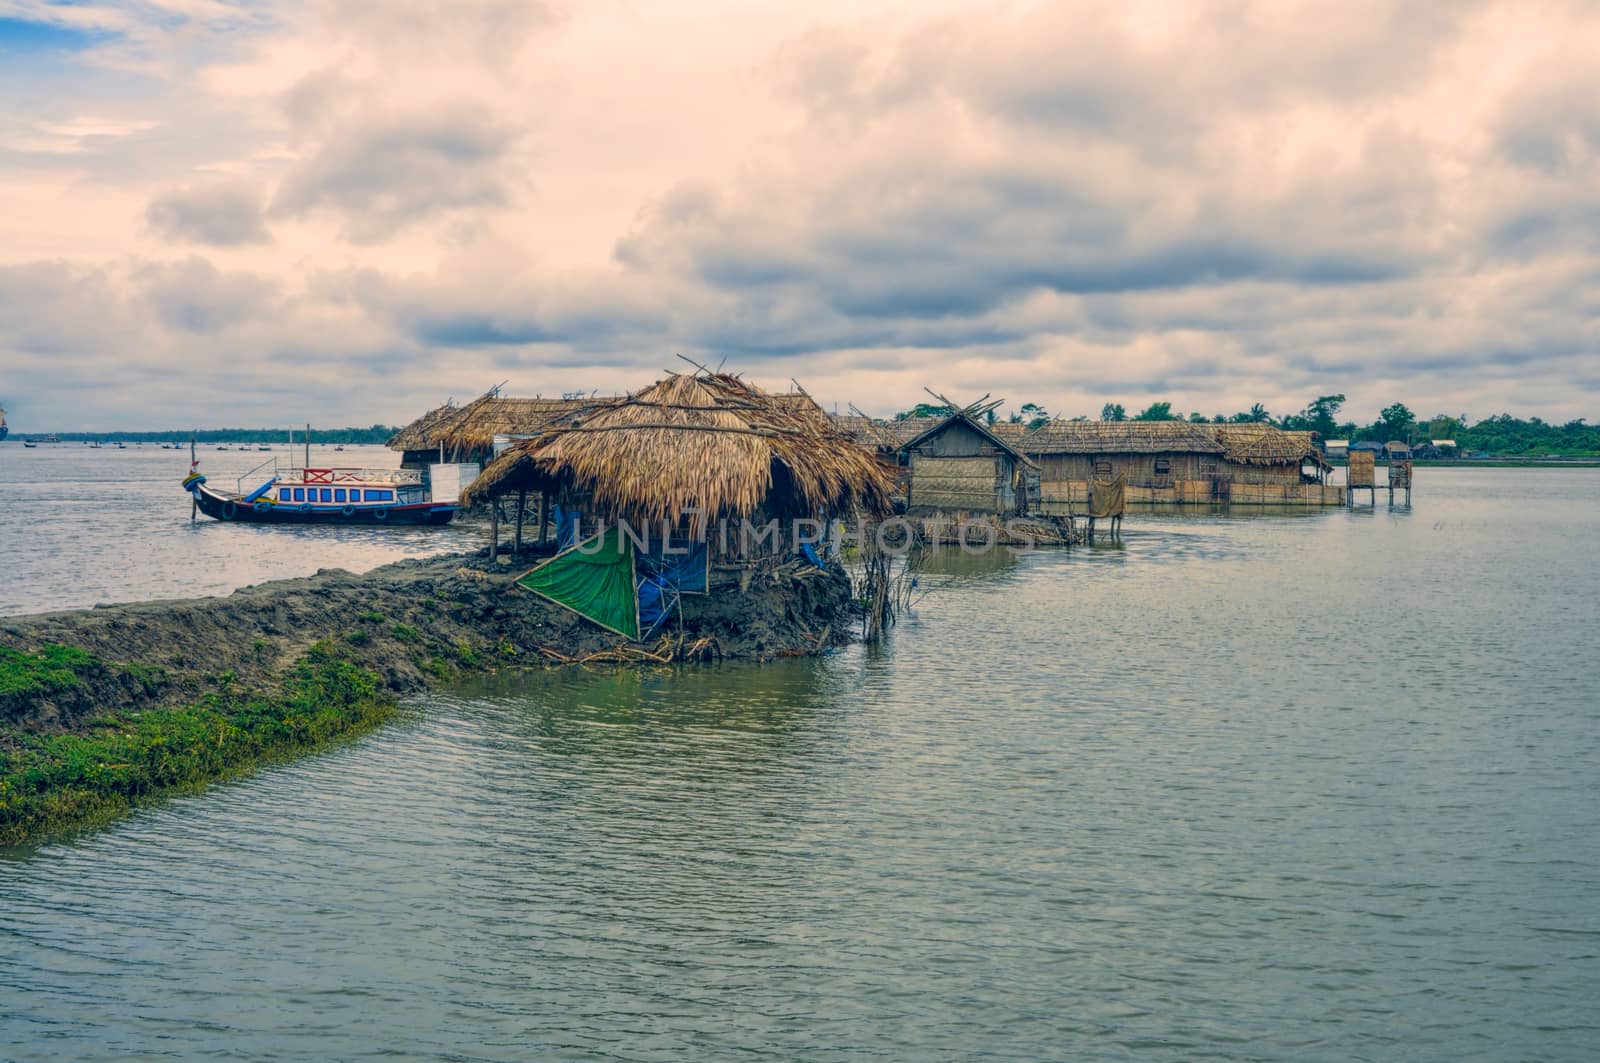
[0, 0, 1600, 429]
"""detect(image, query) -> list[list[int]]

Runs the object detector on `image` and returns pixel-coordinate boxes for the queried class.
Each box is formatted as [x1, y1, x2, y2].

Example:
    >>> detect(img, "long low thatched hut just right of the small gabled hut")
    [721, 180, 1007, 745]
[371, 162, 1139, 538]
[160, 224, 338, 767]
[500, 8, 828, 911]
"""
[1021, 421, 1224, 514]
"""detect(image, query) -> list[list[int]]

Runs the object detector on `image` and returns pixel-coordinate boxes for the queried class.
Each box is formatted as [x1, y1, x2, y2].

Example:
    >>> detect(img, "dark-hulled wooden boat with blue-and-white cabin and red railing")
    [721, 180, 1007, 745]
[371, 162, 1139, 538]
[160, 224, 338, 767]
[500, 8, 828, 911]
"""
[184, 459, 461, 525]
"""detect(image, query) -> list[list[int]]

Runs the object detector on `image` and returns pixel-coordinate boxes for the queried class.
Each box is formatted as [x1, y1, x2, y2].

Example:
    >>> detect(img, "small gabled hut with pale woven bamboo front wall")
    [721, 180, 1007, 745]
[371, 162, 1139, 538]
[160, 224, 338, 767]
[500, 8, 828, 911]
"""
[901, 410, 1034, 515]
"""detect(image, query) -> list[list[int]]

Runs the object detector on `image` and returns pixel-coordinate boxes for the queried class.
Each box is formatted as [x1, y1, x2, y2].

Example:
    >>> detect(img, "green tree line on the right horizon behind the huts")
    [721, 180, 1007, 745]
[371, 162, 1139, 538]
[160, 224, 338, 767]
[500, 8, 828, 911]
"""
[894, 395, 1600, 458]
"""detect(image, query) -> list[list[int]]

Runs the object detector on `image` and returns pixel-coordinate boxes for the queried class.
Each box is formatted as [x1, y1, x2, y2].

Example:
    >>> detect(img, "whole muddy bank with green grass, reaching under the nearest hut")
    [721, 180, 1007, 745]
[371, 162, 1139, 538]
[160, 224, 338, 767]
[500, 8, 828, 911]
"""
[0, 554, 853, 845]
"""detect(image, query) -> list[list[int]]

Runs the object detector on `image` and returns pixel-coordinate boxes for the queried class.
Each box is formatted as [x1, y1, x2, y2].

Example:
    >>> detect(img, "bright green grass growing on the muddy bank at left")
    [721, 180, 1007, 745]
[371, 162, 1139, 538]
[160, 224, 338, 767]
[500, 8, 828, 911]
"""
[0, 642, 395, 845]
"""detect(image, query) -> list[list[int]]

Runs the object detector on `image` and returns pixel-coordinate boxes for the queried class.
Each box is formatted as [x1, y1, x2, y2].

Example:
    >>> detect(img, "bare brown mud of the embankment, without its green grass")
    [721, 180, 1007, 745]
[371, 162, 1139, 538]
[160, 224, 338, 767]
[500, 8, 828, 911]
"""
[0, 554, 851, 732]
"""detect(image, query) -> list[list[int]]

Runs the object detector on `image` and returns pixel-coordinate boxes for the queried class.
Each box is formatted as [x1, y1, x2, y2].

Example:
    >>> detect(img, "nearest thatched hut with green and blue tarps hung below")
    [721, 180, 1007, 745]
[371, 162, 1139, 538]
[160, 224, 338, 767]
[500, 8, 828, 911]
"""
[462, 370, 891, 639]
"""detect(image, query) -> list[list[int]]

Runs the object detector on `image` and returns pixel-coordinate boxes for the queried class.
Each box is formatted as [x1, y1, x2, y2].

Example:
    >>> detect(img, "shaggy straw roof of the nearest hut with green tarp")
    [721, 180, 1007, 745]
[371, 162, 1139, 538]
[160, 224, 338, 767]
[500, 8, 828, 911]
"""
[462, 371, 891, 522]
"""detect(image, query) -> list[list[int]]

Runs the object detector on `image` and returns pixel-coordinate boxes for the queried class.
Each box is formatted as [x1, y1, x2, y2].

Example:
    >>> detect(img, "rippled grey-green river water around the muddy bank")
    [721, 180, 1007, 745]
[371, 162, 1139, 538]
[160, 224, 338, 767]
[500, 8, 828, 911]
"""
[0, 453, 1600, 1061]
